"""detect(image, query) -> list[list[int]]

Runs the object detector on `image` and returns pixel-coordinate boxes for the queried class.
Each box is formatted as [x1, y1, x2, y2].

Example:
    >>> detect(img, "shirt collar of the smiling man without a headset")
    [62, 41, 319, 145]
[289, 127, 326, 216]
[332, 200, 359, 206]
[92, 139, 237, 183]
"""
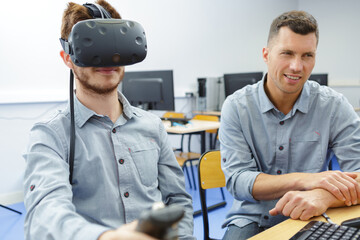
[259, 74, 310, 113]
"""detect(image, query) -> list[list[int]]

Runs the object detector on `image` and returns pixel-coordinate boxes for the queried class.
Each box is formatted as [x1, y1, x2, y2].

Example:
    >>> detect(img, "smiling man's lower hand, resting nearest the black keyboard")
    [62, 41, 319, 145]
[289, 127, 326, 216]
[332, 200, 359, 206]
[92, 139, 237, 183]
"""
[269, 189, 337, 220]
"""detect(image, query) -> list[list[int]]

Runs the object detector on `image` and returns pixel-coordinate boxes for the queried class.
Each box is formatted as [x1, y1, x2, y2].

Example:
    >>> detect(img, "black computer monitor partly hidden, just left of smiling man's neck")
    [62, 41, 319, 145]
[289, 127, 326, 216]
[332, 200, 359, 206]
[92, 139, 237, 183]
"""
[224, 72, 263, 97]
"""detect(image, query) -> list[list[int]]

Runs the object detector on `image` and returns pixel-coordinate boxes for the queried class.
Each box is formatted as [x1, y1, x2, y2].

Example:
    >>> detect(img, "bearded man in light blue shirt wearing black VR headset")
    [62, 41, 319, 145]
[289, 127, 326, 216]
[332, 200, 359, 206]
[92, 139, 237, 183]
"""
[24, 0, 193, 240]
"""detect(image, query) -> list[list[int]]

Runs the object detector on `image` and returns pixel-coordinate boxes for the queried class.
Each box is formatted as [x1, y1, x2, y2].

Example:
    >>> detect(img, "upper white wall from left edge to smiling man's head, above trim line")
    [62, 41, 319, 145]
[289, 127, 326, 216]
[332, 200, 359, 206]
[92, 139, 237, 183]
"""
[0, 0, 297, 102]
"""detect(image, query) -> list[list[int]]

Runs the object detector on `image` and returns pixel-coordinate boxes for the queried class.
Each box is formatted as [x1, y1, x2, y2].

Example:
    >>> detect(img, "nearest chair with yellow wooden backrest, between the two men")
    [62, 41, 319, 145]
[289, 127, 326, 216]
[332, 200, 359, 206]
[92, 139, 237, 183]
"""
[198, 150, 226, 240]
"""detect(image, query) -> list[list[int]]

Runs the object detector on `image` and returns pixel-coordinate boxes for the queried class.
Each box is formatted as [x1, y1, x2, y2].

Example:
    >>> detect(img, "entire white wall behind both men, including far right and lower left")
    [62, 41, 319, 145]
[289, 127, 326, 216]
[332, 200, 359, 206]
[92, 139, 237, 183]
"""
[0, 0, 360, 204]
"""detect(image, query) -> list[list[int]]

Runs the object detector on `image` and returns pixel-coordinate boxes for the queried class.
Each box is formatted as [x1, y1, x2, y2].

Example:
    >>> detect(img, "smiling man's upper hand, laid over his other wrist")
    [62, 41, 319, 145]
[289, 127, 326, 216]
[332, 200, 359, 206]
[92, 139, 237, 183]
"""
[304, 171, 360, 206]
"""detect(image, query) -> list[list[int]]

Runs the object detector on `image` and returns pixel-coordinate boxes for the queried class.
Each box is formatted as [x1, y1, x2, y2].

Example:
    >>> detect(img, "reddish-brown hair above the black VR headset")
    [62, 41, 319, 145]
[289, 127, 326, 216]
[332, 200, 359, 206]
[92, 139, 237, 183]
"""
[61, 0, 121, 39]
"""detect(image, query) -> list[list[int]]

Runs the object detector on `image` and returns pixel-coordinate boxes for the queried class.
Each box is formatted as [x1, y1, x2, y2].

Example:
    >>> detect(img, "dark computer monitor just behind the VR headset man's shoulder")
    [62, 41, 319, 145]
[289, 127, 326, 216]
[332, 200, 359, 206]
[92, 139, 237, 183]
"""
[119, 70, 175, 111]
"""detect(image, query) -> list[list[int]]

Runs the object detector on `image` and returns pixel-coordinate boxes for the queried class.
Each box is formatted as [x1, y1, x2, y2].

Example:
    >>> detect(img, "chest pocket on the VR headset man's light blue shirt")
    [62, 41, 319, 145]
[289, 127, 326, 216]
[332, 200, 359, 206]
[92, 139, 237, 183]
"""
[130, 140, 159, 187]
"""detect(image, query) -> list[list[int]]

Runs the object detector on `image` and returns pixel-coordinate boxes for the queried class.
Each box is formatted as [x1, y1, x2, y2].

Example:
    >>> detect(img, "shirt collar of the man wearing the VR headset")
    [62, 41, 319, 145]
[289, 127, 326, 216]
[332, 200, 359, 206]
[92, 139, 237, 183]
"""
[68, 92, 140, 128]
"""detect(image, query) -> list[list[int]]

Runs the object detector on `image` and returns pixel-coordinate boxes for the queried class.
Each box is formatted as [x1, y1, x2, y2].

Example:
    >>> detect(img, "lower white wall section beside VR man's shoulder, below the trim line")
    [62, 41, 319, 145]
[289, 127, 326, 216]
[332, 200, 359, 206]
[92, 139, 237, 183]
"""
[0, 102, 64, 204]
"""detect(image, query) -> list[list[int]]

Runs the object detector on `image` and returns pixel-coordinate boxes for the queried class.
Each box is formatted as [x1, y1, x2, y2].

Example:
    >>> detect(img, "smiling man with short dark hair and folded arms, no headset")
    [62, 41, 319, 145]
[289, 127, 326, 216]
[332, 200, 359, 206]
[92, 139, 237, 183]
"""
[220, 11, 360, 240]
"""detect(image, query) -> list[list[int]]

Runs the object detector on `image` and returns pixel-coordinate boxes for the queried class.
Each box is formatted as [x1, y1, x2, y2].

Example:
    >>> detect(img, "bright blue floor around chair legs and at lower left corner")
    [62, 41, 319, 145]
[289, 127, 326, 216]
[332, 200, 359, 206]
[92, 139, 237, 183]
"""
[0, 167, 232, 240]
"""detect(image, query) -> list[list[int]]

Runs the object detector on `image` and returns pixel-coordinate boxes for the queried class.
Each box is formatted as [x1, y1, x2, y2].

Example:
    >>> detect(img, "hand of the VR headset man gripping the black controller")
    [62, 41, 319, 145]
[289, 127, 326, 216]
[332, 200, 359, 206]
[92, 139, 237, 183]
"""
[98, 221, 156, 240]
